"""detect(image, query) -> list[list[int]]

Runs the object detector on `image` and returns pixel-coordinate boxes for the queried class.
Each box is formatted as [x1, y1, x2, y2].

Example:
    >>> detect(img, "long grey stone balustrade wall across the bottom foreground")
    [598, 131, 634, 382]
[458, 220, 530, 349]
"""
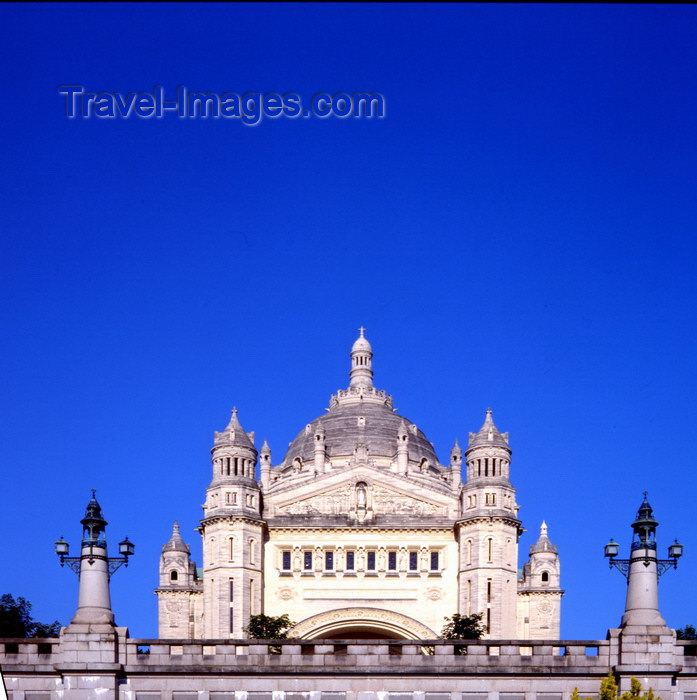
[0, 628, 697, 700]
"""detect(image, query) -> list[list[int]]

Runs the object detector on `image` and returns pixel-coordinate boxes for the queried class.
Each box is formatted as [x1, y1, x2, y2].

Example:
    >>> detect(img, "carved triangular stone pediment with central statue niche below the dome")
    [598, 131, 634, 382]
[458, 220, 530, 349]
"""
[266, 466, 457, 516]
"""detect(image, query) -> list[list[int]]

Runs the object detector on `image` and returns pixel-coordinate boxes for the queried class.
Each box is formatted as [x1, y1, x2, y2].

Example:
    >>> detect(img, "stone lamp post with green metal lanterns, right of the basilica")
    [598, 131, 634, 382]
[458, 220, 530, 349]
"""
[605, 491, 683, 627]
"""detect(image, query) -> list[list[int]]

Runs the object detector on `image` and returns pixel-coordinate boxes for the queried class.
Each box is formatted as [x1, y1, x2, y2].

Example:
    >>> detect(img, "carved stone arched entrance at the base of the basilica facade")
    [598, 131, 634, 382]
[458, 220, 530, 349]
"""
[290, 608, 438, 639]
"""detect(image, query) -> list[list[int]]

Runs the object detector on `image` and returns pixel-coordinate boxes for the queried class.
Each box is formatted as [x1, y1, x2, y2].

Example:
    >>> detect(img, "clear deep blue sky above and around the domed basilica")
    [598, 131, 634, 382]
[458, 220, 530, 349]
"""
[0, 4, 697, 639]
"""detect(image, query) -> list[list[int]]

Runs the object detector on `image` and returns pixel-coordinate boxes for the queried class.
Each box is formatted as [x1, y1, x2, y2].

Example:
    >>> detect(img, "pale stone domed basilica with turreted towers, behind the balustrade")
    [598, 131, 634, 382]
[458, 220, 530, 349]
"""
[156, 329, 563, 640]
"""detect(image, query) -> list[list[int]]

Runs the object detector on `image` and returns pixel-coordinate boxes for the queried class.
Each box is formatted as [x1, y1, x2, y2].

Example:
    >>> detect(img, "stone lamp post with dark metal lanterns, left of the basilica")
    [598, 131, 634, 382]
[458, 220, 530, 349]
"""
[55, 489, 135, 625]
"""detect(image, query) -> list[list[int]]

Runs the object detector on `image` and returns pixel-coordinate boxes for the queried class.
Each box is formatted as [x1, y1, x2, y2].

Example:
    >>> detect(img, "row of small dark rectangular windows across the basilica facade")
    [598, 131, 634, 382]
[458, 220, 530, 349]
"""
[280, 547, 442, 573]
